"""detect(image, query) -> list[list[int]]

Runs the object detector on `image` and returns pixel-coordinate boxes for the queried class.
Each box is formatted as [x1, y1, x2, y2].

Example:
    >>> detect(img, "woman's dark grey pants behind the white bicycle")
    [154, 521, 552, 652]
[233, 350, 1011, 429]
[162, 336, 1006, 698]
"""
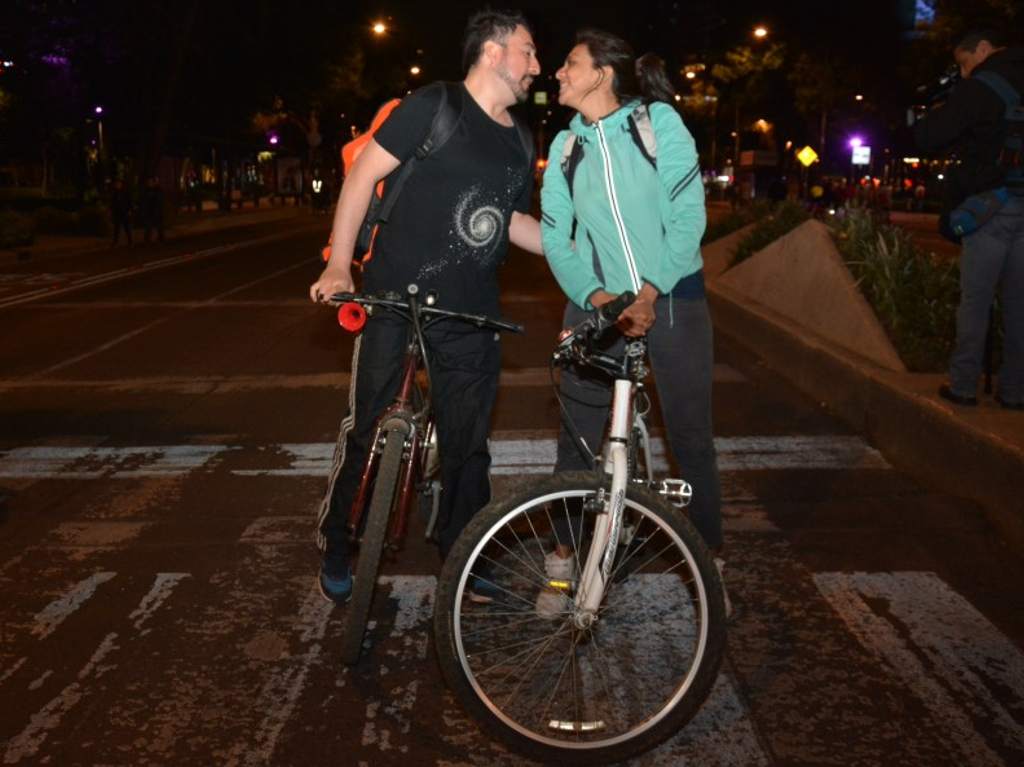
[555, 296, 722, 549]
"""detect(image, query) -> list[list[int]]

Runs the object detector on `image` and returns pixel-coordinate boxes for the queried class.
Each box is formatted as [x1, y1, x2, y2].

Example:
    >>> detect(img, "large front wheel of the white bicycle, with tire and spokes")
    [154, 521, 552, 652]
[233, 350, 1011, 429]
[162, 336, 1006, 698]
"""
[434, 473, 726, 764]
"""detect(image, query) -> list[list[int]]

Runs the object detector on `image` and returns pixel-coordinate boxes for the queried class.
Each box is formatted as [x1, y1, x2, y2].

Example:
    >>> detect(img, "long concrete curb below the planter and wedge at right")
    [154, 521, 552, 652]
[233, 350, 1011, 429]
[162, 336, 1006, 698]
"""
[708, 284, 1024, 551]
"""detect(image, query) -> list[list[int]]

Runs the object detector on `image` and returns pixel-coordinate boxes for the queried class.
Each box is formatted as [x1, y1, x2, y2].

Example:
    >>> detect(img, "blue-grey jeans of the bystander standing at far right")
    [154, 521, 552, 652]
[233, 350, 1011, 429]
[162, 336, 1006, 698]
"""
[949, 196, 1024, 404]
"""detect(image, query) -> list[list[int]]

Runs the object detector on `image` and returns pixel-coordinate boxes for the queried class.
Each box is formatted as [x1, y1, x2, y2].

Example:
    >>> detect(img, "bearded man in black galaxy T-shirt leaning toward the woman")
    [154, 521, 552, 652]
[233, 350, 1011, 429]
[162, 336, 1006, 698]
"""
[309, 11, 541, 603]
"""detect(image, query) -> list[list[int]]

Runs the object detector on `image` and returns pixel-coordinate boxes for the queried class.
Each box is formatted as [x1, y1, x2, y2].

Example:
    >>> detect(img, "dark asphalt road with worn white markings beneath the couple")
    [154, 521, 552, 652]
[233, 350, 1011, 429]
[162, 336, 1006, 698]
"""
[0, 218, 1024, 767]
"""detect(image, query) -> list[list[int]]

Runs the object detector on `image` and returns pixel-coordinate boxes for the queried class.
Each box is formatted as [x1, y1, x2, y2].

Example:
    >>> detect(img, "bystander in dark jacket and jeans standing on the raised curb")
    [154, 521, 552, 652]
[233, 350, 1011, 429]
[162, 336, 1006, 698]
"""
[914, 30, 1024, 410]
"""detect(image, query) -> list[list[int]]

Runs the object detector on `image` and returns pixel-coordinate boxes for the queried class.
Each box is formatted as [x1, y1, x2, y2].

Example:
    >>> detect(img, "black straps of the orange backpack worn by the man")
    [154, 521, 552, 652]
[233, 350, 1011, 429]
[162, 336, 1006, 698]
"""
[353, 82, 534, 261]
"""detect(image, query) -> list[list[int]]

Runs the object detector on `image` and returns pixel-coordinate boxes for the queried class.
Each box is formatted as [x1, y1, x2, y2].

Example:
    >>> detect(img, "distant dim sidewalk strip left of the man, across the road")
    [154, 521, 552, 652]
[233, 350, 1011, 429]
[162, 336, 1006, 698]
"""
[0, 201, 329, 267]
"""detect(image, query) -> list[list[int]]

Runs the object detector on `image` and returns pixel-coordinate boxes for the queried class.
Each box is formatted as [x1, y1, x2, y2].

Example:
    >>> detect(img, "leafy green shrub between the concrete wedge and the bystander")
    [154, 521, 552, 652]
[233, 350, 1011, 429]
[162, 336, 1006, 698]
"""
[833, 207, 959, 373]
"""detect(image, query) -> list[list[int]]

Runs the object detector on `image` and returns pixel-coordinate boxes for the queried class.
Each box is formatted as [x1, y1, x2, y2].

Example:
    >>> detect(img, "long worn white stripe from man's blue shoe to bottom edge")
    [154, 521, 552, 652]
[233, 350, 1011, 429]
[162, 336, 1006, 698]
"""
[224, 587, 334, 767]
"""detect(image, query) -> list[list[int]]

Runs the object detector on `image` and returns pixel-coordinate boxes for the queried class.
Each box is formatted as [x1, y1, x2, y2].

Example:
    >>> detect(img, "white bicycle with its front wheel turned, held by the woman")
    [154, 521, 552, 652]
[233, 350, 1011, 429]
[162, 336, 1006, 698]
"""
[434, 295, 726, 764]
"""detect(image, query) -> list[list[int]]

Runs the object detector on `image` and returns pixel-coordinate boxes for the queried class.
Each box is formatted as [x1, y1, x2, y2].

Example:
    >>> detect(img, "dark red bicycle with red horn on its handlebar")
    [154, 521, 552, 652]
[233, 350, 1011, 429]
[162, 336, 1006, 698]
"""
[328, 285, 523, 666]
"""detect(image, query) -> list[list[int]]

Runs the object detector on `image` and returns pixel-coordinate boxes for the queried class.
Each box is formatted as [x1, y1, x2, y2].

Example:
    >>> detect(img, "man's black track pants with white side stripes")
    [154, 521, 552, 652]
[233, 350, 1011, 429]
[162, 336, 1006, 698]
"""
[317, 315, 501, 576]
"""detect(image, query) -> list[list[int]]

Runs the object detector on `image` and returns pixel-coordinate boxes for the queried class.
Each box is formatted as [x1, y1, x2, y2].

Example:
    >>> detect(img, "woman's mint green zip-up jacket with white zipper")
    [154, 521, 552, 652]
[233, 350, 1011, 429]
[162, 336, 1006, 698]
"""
[541, 101, 706, 309]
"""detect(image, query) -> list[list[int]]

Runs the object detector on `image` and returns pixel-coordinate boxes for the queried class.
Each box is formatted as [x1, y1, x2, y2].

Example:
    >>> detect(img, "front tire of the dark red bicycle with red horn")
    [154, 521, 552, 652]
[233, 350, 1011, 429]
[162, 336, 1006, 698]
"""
[341, 428, 406, 666]
